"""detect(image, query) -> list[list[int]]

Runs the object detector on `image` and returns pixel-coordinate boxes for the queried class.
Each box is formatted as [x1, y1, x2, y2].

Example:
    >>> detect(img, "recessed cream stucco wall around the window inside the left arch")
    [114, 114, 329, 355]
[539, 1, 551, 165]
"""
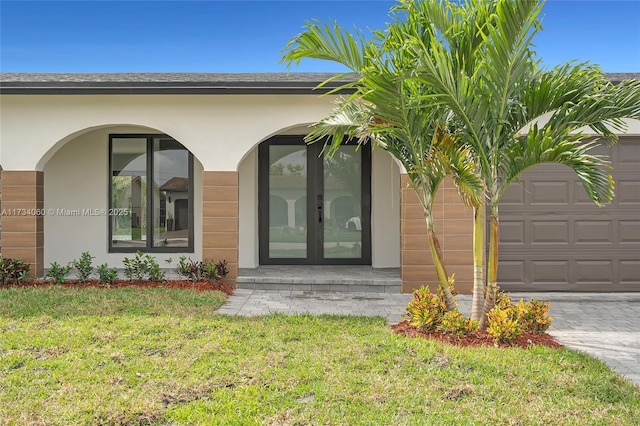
[44, 126, 202, 267]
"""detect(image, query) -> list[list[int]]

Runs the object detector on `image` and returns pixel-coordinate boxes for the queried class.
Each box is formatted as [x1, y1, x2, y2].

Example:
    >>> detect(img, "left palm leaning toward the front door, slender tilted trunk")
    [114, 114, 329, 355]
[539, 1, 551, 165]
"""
[283, 14, 482, 309]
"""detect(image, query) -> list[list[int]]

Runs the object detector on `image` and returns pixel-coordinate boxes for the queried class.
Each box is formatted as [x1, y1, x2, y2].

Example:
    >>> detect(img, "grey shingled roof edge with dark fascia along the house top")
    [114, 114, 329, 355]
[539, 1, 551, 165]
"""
[0, 73, 640, 94]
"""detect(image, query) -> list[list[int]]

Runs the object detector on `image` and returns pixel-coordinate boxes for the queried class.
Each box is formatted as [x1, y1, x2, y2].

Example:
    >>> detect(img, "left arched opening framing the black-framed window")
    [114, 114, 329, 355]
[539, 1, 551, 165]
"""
[43, 126, 202, 267]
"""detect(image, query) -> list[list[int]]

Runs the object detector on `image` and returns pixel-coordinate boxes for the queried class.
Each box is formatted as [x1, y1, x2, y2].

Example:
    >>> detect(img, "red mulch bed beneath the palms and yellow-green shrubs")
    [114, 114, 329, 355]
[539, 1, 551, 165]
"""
[391, 320, 563, 349]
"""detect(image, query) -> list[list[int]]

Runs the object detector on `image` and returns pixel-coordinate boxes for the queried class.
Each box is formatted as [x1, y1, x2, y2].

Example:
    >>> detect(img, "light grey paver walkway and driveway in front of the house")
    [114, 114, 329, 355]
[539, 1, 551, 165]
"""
[218, 289, 640, 385]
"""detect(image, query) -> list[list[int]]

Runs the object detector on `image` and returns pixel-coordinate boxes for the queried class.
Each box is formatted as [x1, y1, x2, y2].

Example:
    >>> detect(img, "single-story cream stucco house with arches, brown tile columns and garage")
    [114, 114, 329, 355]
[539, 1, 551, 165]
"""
[0, 73, 640, 292]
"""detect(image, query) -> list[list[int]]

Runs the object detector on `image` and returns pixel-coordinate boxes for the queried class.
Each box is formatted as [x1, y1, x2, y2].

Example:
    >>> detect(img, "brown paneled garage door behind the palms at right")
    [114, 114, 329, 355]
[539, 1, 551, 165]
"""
[498, 137, 640, 291]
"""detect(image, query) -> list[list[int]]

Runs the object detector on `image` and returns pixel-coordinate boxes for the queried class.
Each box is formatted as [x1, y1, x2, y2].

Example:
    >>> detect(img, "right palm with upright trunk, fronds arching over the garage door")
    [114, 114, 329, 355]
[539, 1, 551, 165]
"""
[400, 0, 640, 323]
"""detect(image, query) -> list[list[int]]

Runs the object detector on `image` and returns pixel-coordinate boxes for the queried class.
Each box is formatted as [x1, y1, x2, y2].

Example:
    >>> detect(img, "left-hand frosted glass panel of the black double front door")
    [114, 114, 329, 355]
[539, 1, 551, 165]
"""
[268, 145, 307, 259]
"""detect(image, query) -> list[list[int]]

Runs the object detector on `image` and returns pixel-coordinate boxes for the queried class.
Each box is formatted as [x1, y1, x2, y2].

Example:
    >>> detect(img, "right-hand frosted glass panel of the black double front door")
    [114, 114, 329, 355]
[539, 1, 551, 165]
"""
[323, 145, 362, 259]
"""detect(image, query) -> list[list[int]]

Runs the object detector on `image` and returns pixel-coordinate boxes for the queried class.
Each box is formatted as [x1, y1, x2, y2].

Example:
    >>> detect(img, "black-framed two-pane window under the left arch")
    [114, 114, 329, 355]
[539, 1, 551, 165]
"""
[109, 135, 193, 252]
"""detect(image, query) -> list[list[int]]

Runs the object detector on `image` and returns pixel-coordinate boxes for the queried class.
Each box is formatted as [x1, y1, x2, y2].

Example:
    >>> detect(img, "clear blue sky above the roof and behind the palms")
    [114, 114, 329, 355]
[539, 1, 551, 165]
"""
[0, 0, 640, 72]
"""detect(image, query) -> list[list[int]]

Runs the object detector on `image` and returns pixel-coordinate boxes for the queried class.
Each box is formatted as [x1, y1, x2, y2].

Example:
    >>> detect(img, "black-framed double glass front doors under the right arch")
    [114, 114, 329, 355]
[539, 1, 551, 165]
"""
[258, 136, 371, 265]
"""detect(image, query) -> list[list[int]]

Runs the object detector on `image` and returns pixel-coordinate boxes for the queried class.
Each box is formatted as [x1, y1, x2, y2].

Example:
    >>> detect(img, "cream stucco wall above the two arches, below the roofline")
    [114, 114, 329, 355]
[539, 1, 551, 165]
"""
[0, 95, 333, 171]
